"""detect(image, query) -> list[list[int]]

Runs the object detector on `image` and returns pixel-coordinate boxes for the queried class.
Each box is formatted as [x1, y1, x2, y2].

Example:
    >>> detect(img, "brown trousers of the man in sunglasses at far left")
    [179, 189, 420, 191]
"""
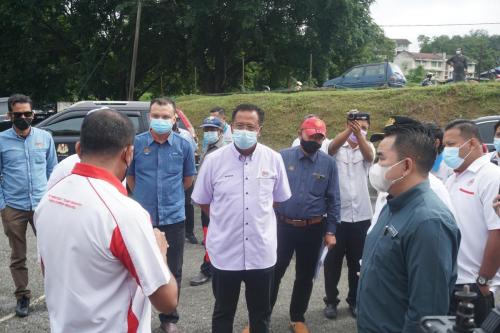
[2, 206, 36, 299]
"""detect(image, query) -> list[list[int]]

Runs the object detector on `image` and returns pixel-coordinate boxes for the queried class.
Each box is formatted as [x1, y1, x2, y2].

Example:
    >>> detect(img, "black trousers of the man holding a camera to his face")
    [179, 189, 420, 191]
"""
[324, 220, 370, 306]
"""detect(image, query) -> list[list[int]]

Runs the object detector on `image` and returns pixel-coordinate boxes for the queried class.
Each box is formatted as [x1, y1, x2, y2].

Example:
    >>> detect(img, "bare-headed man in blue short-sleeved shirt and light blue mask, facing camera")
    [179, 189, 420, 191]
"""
[127, 98, 196, 332]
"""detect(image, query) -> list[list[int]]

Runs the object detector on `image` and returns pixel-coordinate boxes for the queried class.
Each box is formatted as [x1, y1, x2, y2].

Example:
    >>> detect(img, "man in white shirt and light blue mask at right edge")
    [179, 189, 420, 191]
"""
[443, 120, 500, 326]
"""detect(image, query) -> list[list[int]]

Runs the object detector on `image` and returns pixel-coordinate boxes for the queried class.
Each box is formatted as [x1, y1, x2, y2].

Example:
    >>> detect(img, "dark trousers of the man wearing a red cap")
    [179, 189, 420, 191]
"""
[271, 222, 324, 322]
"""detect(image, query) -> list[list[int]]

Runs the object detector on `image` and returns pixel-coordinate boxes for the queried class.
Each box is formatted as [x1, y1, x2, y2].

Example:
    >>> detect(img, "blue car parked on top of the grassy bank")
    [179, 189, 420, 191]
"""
[323, 62, 406, 88]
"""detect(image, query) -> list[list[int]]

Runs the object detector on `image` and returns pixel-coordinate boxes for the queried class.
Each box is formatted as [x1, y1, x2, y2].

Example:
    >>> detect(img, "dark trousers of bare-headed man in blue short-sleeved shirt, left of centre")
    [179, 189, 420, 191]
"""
[155, 221, 186, 323]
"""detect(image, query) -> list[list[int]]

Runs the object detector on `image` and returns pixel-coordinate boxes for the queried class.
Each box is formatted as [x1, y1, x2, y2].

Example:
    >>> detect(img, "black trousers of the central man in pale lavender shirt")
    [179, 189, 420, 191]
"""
[212, 267, 274, 333]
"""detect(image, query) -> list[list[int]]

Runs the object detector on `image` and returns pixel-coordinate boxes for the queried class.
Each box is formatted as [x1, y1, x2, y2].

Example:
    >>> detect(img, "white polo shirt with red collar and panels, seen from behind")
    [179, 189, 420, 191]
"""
[35, 163, 170, 333]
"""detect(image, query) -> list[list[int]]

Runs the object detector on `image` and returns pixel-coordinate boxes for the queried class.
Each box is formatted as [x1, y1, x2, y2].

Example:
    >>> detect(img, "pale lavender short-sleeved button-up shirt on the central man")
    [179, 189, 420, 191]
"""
[191, 143, 291, 271]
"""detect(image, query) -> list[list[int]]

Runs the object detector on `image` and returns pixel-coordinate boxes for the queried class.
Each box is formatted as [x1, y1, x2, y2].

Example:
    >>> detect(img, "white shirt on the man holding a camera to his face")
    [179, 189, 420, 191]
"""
[334, 141, 375, 222]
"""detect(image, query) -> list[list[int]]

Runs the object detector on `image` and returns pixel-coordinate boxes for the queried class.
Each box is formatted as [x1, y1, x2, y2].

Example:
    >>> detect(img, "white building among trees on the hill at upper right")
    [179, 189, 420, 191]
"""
[394, 51, 476, 81]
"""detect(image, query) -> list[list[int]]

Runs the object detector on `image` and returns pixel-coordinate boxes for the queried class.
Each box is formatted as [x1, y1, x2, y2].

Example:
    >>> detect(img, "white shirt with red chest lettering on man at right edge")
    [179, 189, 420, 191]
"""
[446, 155, 500, 289]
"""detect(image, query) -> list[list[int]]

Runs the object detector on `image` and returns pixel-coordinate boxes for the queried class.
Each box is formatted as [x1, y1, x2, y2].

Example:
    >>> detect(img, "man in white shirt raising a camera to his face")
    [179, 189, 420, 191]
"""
[324, 110, 375, 319]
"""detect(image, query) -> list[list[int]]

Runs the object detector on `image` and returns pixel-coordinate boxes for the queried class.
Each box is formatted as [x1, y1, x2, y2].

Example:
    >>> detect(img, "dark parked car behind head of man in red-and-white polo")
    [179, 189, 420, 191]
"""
[37, 101, 197, 161]
